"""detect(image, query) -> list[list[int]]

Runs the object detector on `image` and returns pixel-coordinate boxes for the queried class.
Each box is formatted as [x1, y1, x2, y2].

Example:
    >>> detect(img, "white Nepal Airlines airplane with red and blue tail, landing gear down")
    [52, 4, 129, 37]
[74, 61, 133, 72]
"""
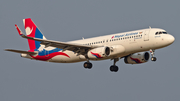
[5, 18, 175, 72]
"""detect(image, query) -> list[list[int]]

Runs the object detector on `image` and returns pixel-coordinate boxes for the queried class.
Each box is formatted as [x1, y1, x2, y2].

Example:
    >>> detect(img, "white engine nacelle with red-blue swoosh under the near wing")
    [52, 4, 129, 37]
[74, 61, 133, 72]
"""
[87, 47, 111, 59]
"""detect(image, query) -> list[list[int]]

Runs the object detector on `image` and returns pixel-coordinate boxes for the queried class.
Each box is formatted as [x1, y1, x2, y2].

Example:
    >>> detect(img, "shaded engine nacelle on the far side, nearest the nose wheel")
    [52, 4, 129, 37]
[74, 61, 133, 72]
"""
[124, 52, 149, 64]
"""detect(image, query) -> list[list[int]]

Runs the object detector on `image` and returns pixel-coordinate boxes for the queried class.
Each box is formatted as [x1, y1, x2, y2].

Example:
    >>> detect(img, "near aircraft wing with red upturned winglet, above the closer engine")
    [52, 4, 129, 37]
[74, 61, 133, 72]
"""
[15, 25, 101, 55]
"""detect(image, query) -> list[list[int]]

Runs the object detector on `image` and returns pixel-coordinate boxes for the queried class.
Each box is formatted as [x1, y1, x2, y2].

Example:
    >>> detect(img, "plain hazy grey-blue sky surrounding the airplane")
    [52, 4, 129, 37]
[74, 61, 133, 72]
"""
[0, 0, 180, 101]
